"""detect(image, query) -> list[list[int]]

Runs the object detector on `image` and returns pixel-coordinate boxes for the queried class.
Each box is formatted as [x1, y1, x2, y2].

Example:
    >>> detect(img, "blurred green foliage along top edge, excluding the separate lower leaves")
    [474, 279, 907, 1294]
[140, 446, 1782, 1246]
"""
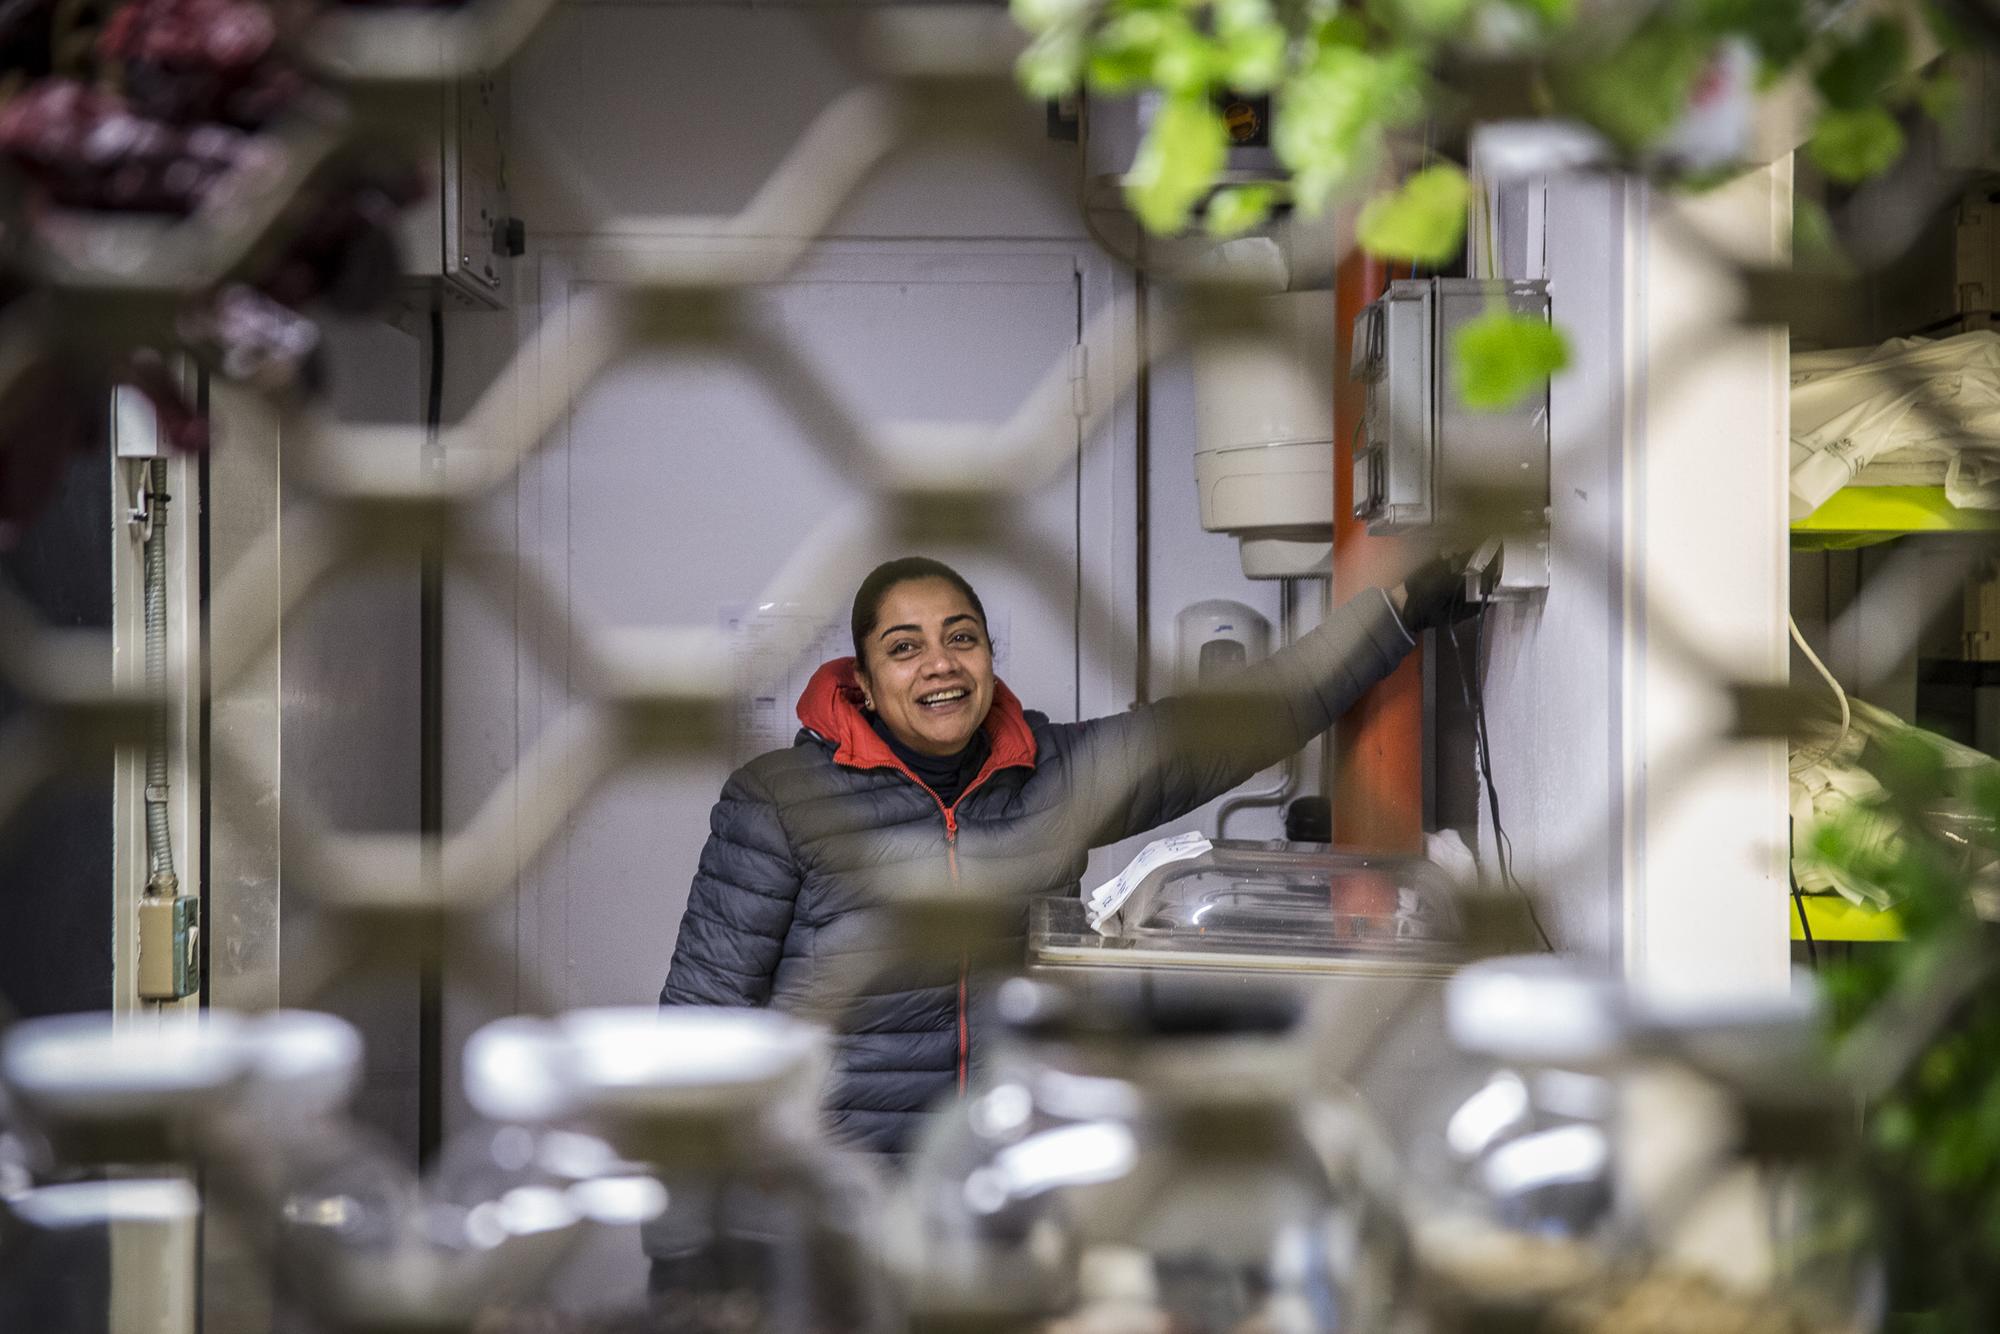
[1012, 0, 1956, 243]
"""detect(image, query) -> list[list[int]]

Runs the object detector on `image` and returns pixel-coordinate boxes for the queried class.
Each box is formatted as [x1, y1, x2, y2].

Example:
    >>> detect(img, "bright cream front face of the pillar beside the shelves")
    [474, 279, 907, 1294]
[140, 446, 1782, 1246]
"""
[1624, 156, 1792, 992]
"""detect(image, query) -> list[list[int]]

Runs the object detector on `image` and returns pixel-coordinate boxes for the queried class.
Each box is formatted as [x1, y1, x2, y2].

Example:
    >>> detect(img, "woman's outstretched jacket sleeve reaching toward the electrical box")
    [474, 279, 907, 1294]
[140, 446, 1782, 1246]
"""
[1070, 588, 1416, 848]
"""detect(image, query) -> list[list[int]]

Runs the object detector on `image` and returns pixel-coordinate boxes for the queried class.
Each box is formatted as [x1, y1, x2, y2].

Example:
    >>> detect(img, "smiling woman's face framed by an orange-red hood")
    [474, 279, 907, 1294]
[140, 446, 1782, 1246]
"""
[858, 578, 994, 756]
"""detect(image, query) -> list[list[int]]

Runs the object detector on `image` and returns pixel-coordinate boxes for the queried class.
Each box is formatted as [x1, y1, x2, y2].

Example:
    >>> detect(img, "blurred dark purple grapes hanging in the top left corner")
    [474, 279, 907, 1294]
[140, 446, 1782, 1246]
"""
[0, 0, 436, 546]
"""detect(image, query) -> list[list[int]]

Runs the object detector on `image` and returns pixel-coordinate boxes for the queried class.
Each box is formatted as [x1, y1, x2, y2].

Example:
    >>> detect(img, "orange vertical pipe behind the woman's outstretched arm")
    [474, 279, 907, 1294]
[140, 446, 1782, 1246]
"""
[1330, 248, 1424, 852]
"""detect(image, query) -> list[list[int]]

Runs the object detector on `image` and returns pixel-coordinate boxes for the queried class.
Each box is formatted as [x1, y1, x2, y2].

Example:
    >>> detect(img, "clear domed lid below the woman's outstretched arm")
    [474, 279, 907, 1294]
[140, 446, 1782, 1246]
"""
[1032, 836, 1462, 972]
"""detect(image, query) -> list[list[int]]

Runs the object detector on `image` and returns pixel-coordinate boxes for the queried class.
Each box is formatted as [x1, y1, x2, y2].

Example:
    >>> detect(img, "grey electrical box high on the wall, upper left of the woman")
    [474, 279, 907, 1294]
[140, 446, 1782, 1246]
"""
[402, 78, 526, 310]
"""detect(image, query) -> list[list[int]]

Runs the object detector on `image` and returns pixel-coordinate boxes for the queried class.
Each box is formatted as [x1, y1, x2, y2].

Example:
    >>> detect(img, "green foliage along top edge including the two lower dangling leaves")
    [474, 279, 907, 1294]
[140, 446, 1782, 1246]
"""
[1012, 0, 1960, 406]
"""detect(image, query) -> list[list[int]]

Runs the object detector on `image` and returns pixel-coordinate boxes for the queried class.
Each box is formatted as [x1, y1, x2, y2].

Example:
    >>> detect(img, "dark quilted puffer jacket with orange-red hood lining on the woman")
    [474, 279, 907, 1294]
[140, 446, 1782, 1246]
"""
[660, 592, 1412, 1154]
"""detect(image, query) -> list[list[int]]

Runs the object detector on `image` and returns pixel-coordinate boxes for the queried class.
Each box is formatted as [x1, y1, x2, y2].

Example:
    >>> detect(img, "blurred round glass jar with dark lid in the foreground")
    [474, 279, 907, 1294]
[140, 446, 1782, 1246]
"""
[894, 980, 1408, 1334]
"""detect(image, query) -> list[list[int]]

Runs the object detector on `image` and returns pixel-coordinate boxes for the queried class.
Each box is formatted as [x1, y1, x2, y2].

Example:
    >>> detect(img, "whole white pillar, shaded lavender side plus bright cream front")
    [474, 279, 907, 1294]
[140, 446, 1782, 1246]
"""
[1482, 160, 1790, 992]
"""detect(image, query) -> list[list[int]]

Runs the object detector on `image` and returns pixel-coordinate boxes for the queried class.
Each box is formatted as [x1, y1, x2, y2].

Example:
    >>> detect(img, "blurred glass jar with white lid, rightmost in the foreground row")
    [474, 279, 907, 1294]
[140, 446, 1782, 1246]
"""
[1402, 956, 1880, 1334]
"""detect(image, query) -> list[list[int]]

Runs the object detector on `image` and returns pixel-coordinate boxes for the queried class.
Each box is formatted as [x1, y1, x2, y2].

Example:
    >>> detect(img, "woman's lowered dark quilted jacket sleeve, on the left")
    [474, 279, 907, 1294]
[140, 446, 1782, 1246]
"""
[660, 770, 800, 1006]
